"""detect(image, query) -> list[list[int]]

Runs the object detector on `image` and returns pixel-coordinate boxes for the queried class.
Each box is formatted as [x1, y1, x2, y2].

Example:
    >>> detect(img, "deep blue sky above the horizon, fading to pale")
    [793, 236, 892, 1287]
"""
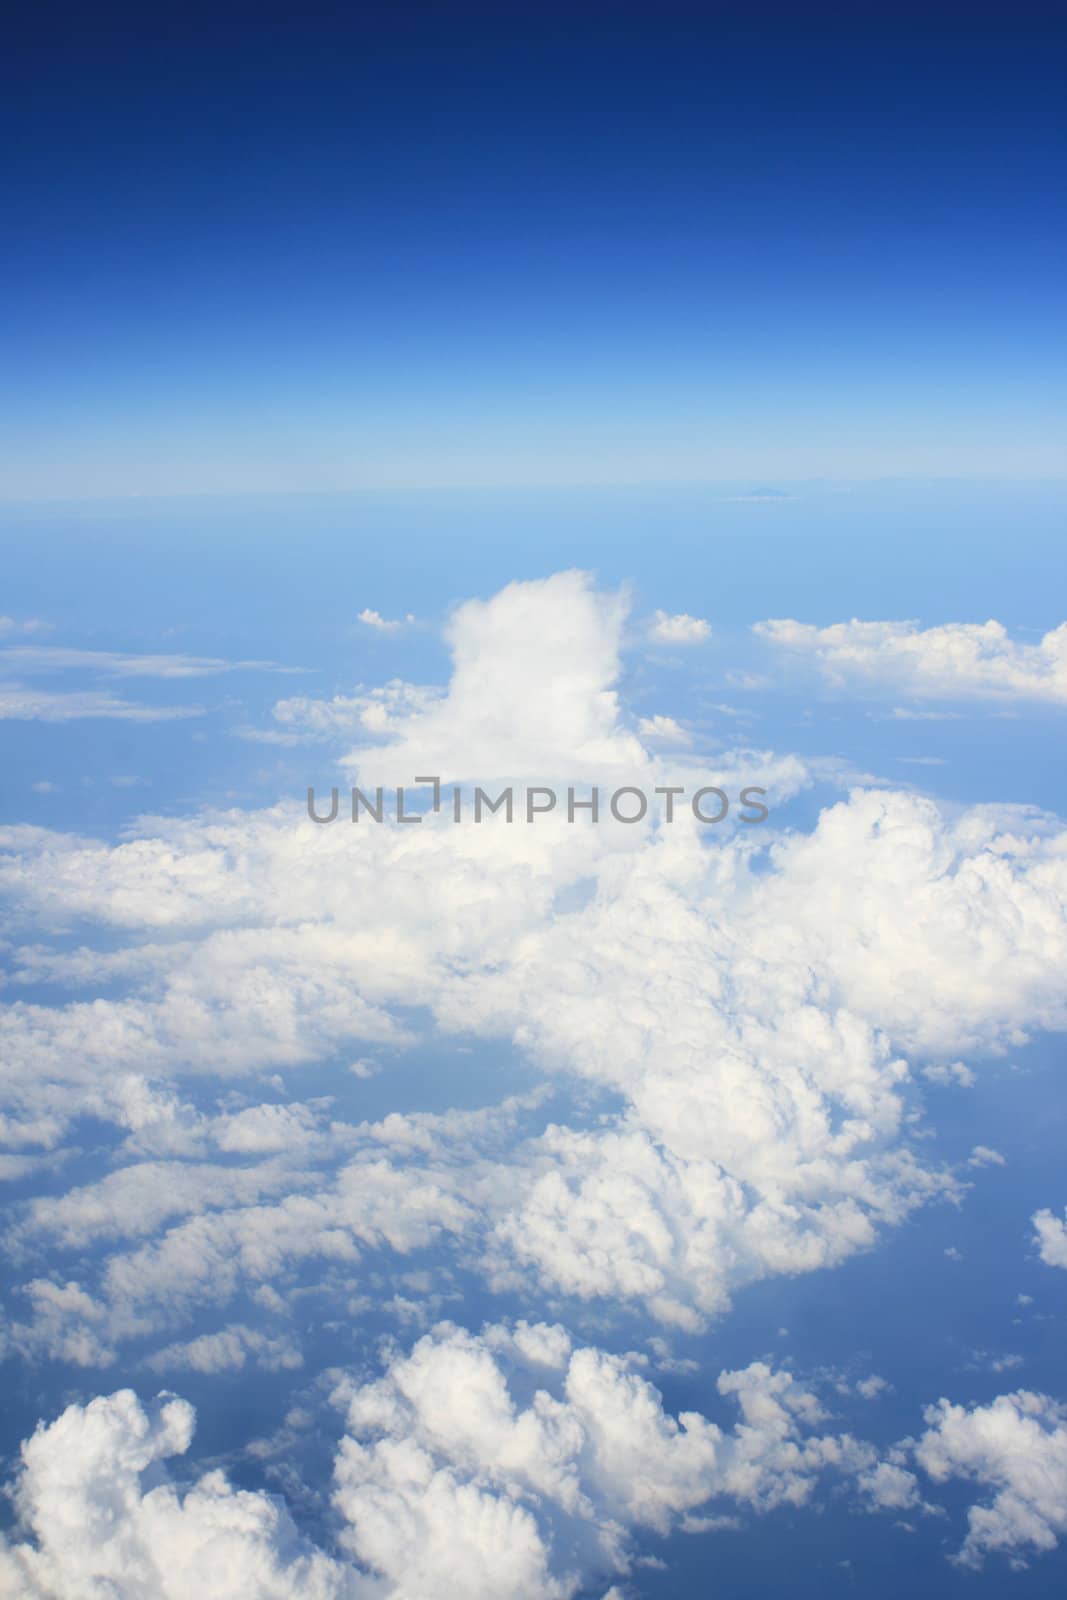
[0, 3, 1067, 498]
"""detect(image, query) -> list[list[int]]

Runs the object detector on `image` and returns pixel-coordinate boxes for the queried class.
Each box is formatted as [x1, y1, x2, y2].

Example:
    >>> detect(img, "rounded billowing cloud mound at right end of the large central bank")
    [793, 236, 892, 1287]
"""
[758, 790, 1067, 1056]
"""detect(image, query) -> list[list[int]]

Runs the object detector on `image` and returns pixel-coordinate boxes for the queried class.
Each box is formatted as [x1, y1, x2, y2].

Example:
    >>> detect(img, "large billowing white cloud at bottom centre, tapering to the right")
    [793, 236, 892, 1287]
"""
[334, 1325, 875, 1600]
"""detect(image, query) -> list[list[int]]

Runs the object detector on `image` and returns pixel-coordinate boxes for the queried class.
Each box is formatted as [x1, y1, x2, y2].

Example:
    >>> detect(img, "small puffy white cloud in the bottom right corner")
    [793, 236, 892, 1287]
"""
[915, 1389, 1067, 1566]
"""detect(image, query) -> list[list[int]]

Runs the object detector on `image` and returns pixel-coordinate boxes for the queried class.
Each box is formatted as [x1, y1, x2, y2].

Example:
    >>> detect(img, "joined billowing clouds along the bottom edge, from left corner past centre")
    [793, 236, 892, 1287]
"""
[0, 1323, 877, 1600]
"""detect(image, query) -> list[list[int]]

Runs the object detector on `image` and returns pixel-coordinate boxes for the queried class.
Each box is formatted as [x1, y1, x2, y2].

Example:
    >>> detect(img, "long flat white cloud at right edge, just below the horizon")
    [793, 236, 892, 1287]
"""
[755, 619, 1067, 702]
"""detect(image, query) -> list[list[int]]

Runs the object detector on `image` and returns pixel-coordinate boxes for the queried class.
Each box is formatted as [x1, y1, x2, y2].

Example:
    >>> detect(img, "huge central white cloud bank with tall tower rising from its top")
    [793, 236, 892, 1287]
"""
[0, 573, 1067, 1350]
